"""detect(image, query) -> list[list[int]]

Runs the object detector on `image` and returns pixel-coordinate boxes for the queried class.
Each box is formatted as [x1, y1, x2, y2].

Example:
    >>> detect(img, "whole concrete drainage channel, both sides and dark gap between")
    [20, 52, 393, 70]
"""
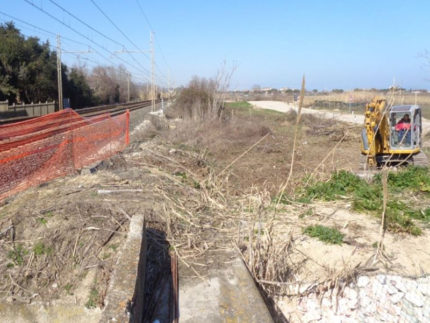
[100, 215, 273, 323]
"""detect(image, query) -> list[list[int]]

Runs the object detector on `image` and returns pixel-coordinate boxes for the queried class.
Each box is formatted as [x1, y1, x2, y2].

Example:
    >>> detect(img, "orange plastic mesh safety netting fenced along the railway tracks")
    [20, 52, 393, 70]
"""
[0, 109, 130, 200]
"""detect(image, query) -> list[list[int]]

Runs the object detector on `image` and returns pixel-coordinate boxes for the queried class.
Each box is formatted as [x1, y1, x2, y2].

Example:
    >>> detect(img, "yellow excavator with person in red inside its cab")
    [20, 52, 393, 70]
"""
[361, 97, 428, 169]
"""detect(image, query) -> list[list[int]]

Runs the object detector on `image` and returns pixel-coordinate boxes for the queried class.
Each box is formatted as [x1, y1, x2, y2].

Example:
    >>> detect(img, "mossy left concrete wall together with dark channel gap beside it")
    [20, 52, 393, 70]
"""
[100, 215, 179, 323]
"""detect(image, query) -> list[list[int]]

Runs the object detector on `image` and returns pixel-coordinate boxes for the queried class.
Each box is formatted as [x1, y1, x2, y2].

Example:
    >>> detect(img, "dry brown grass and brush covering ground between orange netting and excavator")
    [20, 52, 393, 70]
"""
[0, 81, 430, 320]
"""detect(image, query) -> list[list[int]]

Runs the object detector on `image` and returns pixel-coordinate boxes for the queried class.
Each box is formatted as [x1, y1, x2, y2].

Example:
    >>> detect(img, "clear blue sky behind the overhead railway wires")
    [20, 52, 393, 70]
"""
[0, 0, 430, 90]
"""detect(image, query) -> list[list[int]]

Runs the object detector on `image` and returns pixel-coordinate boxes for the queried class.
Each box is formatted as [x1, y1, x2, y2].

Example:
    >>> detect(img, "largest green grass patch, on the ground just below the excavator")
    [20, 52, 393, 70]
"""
[299, 167, 430, 235]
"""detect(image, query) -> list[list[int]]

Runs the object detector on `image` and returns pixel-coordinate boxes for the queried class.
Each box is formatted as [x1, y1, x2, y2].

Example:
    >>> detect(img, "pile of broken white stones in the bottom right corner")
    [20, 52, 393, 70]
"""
[283, 275, 430, 322]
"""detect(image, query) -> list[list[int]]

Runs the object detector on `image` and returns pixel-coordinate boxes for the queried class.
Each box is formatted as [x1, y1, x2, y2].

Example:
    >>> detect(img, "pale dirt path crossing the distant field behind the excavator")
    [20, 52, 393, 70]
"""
[249, 101, 430, 135]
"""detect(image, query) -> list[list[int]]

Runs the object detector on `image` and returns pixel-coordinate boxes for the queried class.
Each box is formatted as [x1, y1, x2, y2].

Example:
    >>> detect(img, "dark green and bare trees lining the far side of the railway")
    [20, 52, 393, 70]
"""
[0, 22, 145, 108]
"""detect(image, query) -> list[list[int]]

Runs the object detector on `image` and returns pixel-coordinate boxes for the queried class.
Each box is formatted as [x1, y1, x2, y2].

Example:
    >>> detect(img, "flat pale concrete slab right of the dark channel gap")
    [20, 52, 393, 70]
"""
[179, 257, 273, 323]
